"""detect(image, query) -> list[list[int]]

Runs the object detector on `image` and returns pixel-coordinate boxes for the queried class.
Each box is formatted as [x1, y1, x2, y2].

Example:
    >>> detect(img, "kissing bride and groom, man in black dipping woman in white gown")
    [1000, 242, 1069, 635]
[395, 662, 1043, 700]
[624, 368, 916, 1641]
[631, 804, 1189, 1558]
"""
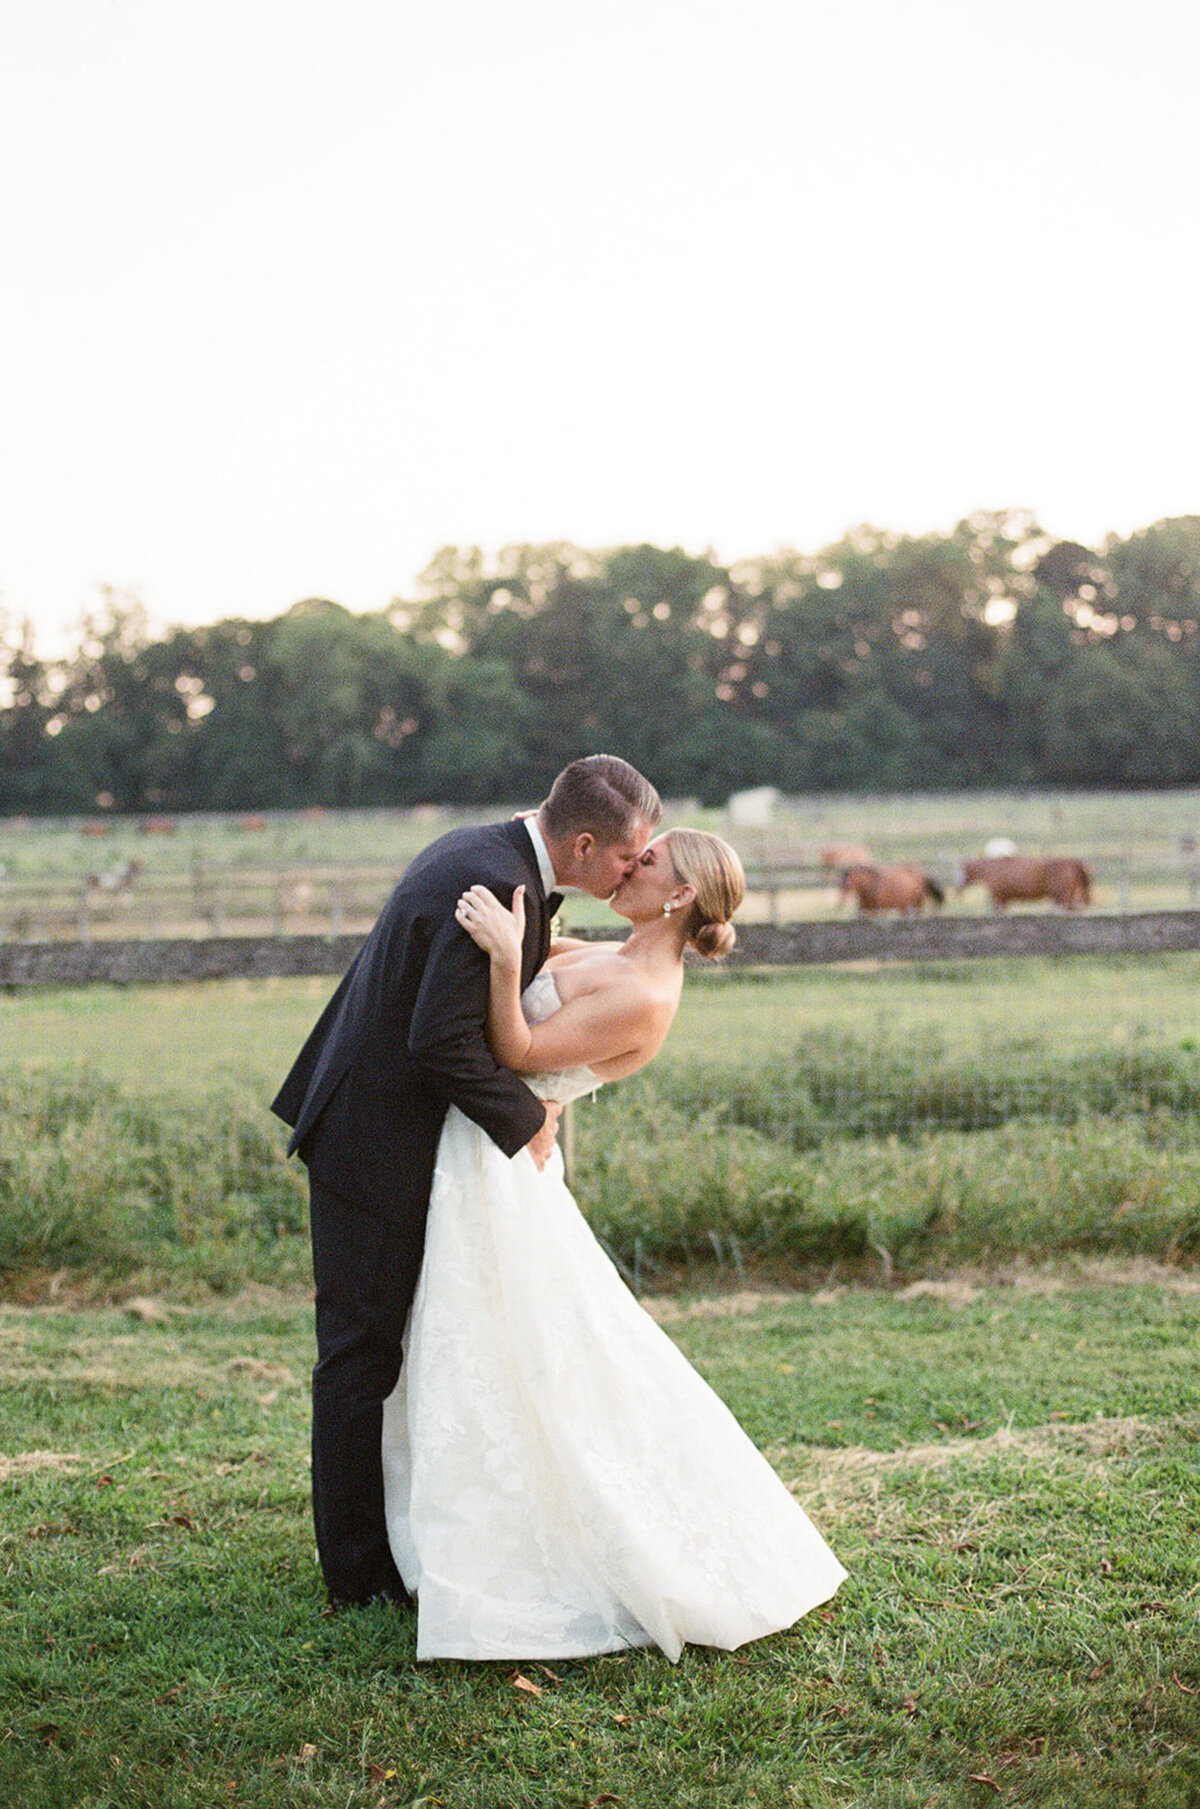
[273, 754, 845, 1659]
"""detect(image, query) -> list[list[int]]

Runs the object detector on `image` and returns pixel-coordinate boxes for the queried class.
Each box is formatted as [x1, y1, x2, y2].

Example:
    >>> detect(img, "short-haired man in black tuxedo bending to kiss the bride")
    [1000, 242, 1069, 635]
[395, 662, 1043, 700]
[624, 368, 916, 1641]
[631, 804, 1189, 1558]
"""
[271, 754, 662, 1605]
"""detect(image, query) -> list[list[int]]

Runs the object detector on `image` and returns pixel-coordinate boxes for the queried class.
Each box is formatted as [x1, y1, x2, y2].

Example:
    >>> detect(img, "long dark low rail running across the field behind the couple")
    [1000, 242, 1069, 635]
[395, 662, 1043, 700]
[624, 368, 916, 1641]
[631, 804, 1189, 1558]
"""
[0, 910, 1200, 990]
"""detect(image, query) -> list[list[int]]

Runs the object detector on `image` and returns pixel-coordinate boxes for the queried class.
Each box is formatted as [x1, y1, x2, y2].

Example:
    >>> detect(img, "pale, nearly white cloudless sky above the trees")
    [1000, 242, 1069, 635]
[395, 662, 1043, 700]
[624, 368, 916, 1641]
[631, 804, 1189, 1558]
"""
[0, 0, 1200, 644]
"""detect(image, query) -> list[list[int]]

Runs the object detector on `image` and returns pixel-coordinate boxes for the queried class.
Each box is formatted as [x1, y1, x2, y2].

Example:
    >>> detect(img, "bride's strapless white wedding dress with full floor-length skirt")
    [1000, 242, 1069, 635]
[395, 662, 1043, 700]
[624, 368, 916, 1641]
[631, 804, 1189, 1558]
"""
[384, 971, 845, 1659]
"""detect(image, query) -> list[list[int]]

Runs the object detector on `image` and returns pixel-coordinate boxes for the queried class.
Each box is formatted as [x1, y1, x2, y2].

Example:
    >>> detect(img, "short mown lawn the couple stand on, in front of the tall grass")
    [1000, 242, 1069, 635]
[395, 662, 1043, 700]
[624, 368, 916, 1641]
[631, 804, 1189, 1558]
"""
[0, 1266, 1200, 1809]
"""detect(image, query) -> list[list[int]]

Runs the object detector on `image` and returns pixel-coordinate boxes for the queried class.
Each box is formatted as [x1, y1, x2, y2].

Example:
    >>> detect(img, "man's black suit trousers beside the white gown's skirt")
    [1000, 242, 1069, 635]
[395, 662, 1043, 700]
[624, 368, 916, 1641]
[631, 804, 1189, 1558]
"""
[310, 1176, 425, 1601]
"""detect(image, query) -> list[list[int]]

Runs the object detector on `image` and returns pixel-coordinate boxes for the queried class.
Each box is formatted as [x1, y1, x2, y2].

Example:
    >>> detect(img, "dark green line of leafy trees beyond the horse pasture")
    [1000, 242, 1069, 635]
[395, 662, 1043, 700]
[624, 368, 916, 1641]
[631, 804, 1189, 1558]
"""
[0, 510, 1200, 814]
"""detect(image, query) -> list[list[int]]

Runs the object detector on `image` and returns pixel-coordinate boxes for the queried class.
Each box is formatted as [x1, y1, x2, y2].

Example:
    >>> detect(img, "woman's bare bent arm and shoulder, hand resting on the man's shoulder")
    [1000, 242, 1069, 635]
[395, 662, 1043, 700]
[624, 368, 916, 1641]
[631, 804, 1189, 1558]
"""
[458, 886, 673, 1078]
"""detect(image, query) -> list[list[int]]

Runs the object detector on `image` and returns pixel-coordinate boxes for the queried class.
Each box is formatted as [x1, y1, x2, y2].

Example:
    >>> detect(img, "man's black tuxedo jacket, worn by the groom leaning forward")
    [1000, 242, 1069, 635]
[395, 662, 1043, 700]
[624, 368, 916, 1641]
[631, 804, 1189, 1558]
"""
[271, 821, 550, 1221]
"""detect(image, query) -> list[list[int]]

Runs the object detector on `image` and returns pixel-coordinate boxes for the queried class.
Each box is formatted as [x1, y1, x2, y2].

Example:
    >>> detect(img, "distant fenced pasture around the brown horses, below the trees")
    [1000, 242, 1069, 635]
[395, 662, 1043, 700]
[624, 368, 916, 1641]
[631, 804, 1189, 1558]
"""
[0, 791, 1200, 939]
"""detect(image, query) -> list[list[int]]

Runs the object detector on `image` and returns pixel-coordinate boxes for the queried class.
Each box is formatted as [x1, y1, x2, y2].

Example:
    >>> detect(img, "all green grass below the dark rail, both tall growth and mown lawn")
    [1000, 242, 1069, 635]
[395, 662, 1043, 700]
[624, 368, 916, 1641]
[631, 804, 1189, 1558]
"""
[0, 955, 1200, 1809]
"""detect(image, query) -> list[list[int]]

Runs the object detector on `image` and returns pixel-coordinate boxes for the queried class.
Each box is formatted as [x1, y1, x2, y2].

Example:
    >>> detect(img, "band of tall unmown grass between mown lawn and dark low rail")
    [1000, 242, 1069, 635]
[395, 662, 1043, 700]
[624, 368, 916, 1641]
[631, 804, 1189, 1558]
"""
[0, 957, 1200, 1290]
